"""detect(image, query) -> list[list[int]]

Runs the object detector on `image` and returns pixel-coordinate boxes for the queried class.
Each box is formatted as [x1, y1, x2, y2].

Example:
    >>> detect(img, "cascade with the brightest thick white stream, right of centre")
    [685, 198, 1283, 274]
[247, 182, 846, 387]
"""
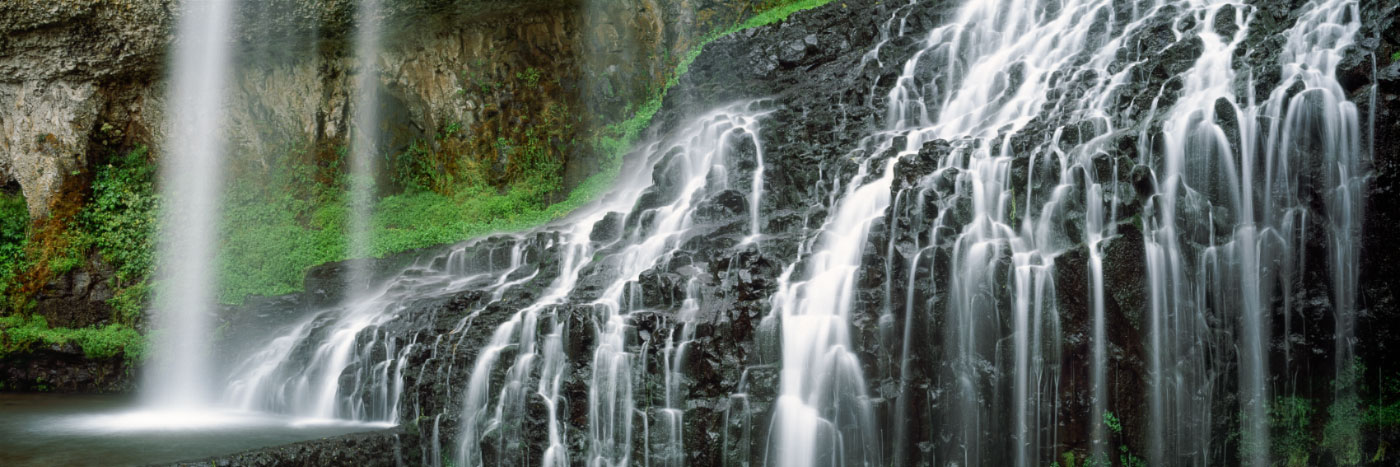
[774, 1, 1159, 466]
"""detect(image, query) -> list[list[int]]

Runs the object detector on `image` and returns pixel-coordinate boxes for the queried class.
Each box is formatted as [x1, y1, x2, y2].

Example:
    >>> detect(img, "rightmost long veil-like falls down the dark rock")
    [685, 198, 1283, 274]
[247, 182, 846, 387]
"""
[1144, 1, 1364, 466]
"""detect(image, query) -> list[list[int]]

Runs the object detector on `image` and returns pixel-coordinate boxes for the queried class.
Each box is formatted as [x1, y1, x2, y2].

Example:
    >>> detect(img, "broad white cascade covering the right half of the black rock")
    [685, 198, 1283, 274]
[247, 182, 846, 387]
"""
[770, 1, 1362, 466]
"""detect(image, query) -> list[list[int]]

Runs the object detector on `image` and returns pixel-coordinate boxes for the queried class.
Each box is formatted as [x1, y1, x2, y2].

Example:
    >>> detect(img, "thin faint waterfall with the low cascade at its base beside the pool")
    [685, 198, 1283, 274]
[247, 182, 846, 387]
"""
[215, 0, 406, 422]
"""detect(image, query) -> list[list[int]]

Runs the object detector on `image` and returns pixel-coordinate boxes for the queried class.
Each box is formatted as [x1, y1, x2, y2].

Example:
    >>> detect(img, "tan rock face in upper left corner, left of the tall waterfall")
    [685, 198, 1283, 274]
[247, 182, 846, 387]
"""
[0, 1, 172, 218]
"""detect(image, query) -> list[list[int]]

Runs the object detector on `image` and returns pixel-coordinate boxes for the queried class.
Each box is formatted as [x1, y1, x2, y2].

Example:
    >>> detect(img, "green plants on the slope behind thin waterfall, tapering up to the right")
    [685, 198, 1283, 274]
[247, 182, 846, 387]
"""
[218, 0, 830, 303]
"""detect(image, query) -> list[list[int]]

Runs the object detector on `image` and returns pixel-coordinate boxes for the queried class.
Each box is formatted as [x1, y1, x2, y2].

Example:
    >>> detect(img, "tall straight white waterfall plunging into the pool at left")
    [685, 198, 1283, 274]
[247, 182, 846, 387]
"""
[143, 0, 234, 408]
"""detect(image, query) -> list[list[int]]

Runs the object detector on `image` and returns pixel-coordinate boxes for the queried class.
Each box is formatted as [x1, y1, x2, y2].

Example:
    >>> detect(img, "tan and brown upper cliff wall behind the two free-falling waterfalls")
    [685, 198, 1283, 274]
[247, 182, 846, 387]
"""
[0, 0, 755, 218]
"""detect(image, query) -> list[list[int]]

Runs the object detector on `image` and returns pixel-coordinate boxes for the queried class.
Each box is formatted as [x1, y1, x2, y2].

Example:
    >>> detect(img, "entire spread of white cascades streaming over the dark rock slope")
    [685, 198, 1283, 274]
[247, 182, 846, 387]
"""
[144, 0, 1365, 466]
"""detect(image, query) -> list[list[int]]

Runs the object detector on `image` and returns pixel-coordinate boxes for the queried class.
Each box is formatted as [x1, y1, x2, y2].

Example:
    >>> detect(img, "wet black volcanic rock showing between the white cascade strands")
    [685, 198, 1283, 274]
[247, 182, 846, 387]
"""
[144, 0, 1400, 466]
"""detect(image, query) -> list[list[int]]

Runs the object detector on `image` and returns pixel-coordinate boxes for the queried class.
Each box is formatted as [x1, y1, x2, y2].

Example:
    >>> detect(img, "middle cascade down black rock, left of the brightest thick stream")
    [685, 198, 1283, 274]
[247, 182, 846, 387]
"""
[456, 102, 764, 466]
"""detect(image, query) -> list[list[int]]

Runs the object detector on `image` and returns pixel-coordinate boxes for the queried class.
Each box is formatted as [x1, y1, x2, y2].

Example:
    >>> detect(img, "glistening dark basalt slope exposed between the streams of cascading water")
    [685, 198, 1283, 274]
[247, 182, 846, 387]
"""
[204, 0, 1400, 466]
